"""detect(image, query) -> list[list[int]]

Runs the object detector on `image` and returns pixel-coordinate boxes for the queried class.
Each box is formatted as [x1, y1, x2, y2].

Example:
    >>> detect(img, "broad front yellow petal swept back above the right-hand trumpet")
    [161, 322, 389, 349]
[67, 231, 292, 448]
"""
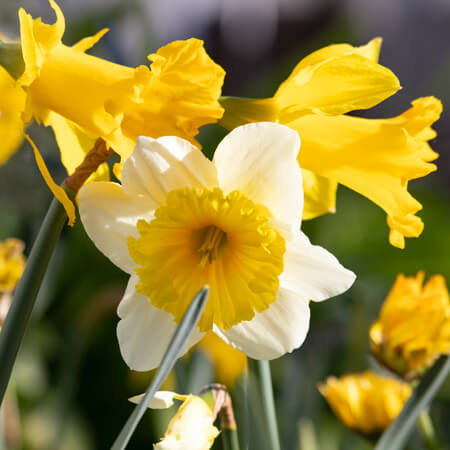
[274, 53, 400, 119]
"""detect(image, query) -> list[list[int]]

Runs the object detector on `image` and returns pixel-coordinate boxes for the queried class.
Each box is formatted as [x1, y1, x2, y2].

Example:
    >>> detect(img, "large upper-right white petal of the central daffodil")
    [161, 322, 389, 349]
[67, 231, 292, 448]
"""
[213, 122, 303, 230]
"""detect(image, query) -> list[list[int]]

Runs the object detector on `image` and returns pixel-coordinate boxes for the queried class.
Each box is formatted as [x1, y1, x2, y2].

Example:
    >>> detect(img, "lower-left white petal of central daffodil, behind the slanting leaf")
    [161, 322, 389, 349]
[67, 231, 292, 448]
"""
[117, 275, 205, 371]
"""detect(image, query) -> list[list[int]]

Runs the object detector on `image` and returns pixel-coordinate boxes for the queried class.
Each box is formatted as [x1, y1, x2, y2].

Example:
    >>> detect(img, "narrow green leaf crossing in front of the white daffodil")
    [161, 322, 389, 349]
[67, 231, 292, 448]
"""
[111, 287, 209, 450]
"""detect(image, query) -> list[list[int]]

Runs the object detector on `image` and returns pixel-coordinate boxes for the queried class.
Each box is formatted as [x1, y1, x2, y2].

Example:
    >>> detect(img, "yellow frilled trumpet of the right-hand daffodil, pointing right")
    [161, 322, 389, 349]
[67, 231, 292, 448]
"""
[289, 97, 441, 247]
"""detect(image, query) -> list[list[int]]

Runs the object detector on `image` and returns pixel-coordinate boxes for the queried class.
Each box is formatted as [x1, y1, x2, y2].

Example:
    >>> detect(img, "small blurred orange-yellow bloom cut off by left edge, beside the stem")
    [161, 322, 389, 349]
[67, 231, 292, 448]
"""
[0, 238, 26, 293]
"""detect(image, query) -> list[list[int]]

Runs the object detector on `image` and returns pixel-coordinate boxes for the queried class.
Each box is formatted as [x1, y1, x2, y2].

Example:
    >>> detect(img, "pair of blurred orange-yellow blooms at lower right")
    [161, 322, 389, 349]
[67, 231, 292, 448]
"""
[319, 271, 450, 434]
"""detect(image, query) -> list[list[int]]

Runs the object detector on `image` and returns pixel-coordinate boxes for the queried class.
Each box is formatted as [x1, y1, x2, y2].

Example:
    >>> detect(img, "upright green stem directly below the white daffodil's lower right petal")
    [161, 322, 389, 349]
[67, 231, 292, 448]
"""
[249, 358, 281, 450]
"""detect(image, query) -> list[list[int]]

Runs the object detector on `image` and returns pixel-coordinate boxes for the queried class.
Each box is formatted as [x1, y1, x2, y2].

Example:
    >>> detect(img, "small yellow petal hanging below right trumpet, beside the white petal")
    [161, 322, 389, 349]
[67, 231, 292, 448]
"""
[302, 169, 338, 220]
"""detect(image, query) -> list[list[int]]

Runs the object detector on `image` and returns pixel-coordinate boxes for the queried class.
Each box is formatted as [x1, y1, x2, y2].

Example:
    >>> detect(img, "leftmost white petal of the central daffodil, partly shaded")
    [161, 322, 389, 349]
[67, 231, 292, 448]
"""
[78, 181, 155, 273]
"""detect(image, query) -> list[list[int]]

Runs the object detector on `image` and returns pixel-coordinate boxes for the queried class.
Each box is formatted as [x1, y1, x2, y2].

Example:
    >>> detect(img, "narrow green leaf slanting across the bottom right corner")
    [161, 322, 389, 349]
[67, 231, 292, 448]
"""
[374, 356, 450, 450]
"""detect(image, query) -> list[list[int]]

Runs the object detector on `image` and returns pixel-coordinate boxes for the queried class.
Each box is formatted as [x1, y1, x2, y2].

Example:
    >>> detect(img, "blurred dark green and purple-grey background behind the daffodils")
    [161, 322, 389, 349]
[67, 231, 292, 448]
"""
[0, 0, 450, 450]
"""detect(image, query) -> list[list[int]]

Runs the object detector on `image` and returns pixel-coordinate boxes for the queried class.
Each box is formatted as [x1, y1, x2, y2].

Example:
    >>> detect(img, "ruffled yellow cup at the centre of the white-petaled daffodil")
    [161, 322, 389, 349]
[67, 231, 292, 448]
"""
[128, 188, 285, 331]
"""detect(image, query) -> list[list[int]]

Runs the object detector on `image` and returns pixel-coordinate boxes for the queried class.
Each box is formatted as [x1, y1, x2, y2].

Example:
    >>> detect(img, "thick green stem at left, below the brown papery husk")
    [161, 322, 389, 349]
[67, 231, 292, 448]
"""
[0, 189, 75, 404]
